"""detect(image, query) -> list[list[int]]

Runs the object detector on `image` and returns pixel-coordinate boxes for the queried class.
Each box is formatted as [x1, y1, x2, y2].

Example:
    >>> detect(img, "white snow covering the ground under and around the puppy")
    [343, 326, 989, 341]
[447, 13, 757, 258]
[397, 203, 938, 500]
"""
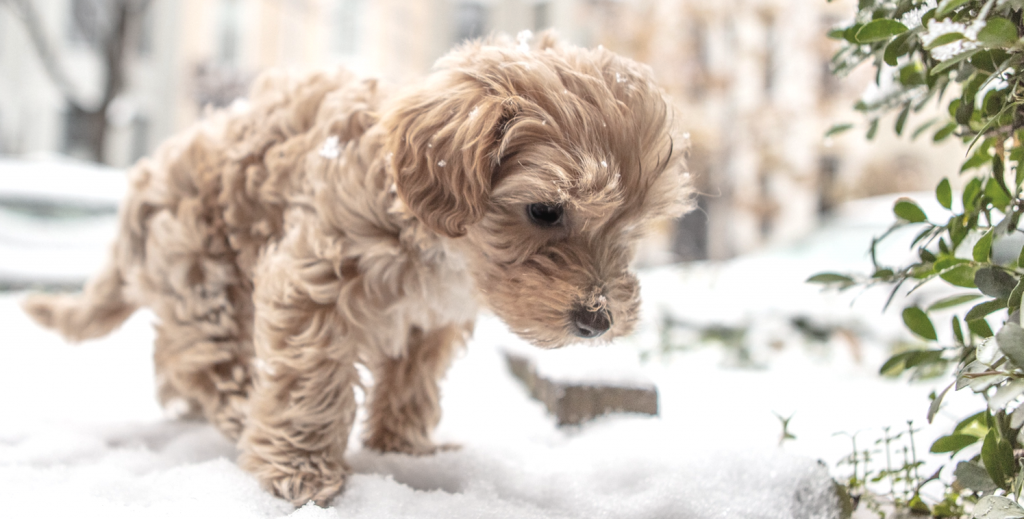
[0, 178, 975, 519]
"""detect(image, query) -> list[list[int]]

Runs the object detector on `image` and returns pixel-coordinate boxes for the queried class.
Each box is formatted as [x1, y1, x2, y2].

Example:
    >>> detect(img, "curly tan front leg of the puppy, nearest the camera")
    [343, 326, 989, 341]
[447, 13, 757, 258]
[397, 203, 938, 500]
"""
[239, 247, 357, 506]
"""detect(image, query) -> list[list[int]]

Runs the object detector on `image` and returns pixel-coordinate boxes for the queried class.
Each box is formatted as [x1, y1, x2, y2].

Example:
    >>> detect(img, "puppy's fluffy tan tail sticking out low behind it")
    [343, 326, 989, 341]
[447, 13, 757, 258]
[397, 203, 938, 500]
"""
[22, 261, 138, 342]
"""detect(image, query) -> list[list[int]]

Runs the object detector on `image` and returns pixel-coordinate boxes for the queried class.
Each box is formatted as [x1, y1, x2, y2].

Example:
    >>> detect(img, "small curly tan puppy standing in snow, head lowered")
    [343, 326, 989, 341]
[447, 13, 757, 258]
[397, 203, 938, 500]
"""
[24, 34, 692, 506]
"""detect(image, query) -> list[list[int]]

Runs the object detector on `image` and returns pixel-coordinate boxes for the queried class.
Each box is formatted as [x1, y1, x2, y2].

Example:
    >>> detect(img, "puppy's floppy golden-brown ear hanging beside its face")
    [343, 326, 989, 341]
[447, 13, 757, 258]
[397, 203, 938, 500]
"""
[382, 81, 518, 236]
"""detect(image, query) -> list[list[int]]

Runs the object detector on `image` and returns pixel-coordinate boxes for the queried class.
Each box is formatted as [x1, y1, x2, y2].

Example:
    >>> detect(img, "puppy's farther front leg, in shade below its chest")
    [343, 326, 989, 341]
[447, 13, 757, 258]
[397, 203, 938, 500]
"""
[362, 325, 470, 455]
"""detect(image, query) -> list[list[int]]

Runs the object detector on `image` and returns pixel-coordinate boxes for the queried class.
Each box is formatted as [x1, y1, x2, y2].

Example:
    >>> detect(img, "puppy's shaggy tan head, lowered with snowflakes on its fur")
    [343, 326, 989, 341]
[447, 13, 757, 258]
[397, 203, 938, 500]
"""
[382, 34, 692, 347]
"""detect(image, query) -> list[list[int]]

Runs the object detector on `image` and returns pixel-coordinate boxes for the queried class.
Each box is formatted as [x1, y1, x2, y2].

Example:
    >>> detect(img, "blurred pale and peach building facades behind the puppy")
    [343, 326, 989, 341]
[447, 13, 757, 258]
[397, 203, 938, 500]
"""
[0, 0, 963, 262]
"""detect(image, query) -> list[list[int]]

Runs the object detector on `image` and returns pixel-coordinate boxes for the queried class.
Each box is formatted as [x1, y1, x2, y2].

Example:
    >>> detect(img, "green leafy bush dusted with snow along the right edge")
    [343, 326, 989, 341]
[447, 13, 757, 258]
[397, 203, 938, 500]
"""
[809, 0, 1024, 513]
